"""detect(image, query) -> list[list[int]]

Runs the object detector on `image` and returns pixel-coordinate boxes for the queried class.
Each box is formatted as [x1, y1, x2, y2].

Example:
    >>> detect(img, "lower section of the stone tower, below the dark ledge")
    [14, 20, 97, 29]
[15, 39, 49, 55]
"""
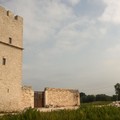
[0, 44, 22, 112]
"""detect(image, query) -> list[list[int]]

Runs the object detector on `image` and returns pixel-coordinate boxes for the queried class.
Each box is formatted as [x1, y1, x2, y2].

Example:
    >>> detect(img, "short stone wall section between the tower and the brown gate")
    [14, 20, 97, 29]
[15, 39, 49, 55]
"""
[21, 86, 34, 109]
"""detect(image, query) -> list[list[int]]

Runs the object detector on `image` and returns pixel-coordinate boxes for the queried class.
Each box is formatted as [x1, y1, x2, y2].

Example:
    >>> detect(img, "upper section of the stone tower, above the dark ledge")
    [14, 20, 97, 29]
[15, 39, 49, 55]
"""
[0, 6, 23, 48]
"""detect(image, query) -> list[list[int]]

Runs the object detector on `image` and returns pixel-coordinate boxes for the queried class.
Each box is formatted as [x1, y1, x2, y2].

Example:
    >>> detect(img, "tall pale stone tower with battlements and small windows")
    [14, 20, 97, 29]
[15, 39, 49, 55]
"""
[0, 7, 23, 111]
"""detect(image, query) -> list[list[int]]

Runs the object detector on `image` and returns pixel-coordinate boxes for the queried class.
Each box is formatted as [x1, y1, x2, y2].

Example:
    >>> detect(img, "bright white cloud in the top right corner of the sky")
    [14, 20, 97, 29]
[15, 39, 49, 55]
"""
[100, 0, 120, 24]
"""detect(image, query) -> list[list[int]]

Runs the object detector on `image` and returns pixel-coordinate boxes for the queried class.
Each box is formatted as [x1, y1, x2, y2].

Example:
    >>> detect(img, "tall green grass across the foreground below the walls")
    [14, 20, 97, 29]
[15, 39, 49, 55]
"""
[0, 103, 120, 120]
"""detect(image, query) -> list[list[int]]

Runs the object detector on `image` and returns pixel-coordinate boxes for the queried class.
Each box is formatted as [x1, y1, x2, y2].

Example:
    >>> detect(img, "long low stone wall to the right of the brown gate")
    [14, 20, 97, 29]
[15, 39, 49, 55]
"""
[45, 88, 80, 107]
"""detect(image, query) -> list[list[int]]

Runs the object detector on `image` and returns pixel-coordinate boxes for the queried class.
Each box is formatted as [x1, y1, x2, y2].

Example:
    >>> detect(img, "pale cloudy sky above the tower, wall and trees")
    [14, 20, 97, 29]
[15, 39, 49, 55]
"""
[0, 0, 120, 95]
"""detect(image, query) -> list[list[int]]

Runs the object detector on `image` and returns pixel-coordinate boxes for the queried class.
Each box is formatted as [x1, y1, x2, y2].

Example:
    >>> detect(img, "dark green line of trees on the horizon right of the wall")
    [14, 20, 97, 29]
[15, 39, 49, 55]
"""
[80, 83, 120, 103]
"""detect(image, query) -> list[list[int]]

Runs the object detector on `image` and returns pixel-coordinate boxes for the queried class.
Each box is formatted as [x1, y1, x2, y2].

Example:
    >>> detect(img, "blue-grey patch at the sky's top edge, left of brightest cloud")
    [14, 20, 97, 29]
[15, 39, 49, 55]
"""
[74, 0, 106, 19]
